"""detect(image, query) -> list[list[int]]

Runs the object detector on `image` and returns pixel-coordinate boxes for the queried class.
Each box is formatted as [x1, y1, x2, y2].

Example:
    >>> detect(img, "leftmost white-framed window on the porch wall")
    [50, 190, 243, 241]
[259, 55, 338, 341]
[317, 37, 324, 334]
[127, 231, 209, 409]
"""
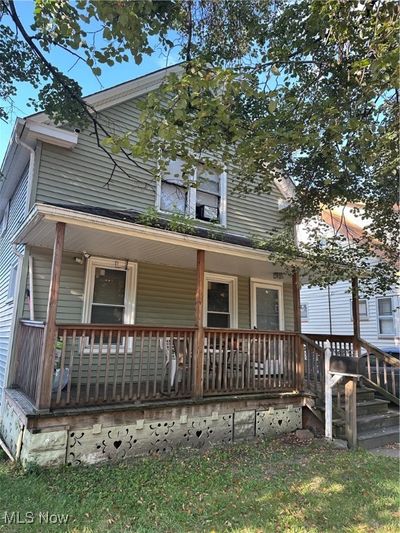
[83, 257, 137, 324]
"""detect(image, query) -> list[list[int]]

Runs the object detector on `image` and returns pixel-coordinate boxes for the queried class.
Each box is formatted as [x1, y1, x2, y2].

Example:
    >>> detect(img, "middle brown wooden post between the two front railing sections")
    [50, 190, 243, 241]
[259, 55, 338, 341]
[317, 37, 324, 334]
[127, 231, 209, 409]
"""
[192, 250, 205, 398]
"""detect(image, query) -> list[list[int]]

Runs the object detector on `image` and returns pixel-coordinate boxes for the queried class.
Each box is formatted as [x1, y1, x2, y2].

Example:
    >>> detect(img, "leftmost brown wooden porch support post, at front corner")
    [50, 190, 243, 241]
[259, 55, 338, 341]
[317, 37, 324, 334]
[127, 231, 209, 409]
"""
[36, 222, 65, 410]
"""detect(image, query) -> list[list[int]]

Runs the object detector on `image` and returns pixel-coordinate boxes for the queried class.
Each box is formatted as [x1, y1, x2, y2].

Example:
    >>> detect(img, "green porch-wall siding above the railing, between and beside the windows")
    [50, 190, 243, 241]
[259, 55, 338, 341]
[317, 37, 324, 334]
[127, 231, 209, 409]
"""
[24, 248, 293, 330]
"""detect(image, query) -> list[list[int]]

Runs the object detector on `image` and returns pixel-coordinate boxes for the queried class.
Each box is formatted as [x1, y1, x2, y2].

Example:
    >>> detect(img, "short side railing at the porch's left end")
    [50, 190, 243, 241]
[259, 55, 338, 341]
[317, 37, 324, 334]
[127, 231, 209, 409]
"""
[14, 320, 44, 402]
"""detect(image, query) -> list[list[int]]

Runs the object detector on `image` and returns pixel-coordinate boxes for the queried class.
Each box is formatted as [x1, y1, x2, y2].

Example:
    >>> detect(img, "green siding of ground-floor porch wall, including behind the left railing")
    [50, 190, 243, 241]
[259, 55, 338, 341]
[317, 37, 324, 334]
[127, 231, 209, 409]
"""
[25, 248, 293, 388]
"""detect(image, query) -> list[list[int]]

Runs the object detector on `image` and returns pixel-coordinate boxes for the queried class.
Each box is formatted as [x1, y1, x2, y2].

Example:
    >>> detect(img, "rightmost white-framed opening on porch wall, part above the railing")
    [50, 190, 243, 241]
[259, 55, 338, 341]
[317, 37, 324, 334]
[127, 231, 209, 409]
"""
[251, 281, 284, 331]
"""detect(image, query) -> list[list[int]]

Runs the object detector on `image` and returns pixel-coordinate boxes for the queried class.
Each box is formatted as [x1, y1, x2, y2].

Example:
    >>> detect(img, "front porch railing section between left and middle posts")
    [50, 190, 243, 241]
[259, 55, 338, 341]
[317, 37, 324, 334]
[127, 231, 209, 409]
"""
[51, 324, 195, 407]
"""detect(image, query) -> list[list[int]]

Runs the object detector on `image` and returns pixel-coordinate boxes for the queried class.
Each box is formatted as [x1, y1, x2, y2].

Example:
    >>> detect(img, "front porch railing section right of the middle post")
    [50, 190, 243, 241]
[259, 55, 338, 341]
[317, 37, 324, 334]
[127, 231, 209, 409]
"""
[203, 328, 298, 395]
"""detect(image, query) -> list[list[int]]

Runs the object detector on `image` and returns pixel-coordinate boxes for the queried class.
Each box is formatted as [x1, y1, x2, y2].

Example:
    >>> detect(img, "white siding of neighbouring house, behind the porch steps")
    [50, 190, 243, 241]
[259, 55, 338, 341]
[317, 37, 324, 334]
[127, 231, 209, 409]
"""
[301, 282, 400, 348]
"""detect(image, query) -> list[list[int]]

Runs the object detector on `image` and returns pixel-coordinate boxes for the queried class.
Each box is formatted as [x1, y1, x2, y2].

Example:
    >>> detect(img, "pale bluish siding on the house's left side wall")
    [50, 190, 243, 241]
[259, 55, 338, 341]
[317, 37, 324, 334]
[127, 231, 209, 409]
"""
[0, 168, 28, 401]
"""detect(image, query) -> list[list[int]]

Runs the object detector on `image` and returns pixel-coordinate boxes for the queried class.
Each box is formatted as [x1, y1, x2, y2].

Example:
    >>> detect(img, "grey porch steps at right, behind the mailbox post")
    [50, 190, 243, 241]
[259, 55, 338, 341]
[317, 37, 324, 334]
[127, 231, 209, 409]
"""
[333, 387, 400, 450]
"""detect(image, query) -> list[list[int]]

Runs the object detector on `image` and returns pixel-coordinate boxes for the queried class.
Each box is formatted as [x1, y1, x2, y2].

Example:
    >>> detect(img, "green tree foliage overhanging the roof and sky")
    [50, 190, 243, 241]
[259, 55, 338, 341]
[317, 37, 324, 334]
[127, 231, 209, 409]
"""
[0, 0, 399, 290]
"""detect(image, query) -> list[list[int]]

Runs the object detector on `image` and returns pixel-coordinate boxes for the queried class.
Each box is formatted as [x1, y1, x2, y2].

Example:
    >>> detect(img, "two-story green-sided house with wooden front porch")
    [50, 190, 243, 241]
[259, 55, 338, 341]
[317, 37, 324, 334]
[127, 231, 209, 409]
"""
[0, 70, 396, 464]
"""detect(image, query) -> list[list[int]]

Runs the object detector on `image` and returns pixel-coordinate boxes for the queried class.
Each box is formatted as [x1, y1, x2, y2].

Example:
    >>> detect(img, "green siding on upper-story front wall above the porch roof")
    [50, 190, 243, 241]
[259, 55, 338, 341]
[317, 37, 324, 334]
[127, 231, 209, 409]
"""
[36, 94, 282, 236]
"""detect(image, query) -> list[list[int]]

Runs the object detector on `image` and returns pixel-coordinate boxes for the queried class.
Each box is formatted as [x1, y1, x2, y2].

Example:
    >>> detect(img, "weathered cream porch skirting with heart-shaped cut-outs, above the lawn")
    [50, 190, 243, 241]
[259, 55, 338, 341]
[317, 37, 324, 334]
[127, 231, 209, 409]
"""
[1, 391, 304, 467]
